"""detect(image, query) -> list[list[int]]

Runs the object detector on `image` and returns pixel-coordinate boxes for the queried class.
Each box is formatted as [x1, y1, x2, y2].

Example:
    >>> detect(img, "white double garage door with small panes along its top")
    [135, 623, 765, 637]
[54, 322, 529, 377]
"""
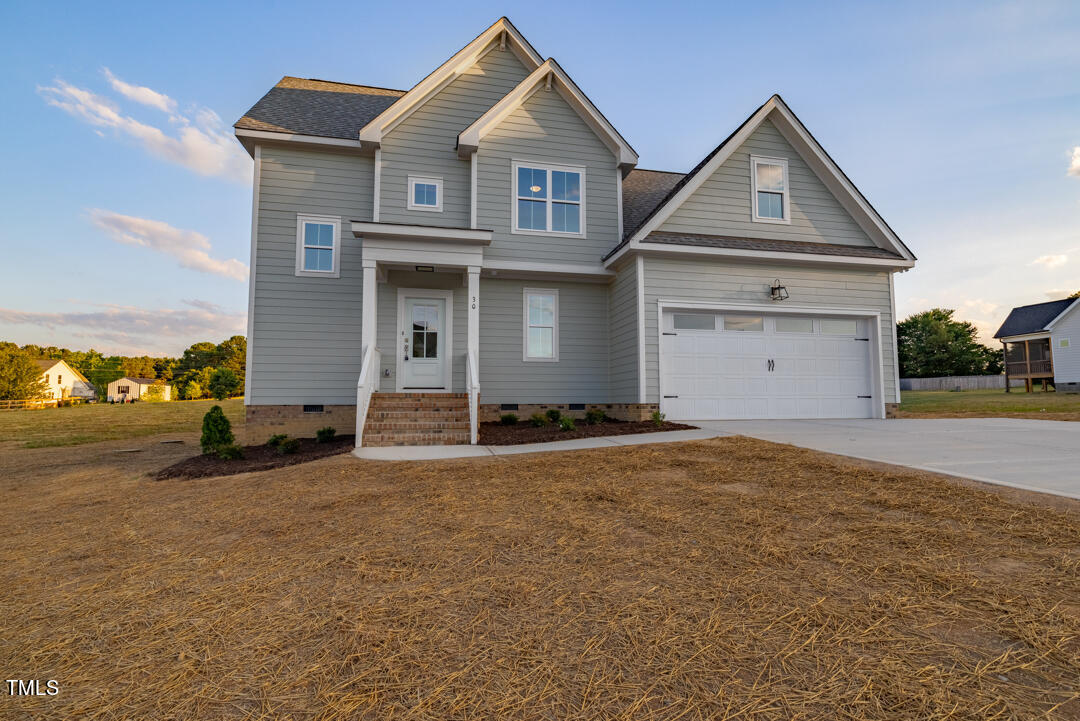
[660, 311, 878, 420]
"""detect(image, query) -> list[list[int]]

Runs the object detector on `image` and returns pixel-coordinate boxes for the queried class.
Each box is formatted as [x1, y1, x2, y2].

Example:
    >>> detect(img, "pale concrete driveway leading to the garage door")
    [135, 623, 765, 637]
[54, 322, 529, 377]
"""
[688, 418, 1080, 499]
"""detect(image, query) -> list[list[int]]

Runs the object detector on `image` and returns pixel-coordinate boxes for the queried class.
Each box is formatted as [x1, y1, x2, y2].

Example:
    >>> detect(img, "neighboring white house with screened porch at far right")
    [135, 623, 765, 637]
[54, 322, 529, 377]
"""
[994, 298, 1080, 393]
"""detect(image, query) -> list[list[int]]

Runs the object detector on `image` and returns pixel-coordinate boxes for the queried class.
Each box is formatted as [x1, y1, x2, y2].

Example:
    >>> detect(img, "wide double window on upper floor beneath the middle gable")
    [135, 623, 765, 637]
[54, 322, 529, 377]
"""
[511, 161, 585, 235]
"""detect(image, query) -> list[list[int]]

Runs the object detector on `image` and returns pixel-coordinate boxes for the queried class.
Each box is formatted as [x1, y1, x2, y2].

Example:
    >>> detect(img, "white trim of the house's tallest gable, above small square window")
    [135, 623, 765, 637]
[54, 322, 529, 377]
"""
[359, 17, 542, 149]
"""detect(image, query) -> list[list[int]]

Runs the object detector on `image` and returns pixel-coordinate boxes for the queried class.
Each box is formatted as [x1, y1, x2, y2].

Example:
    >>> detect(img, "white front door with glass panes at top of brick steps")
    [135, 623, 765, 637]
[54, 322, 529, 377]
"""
[400, 297, 447, 391]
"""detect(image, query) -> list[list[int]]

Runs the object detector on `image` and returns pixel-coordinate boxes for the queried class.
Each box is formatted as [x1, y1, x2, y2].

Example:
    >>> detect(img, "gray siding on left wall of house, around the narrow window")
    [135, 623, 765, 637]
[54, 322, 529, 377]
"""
[247, 146, 374, 405]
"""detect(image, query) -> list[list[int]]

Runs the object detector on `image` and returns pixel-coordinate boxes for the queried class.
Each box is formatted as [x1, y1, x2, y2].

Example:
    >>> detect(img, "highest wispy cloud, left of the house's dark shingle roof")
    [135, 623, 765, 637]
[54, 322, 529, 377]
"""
[38, 80, 252, 182]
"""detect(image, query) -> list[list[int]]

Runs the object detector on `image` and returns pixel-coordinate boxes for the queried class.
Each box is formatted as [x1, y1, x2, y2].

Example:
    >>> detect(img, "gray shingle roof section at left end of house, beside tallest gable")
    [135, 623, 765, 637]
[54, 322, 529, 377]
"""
[233, 76, 405, 140]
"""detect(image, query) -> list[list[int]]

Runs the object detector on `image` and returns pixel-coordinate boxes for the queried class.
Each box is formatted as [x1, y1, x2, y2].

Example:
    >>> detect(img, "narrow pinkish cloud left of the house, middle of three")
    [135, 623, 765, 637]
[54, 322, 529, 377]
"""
[90, 208, 247, 281]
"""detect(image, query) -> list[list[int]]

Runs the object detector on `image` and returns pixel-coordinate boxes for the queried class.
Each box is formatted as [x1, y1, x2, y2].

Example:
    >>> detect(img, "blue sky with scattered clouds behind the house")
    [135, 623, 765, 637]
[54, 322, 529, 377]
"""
[0, 2, 1080, 354]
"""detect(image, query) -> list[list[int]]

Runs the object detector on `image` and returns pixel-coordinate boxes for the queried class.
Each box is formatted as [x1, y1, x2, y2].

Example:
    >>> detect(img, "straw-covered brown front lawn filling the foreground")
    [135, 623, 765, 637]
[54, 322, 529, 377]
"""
[0, 431, 1080, 721]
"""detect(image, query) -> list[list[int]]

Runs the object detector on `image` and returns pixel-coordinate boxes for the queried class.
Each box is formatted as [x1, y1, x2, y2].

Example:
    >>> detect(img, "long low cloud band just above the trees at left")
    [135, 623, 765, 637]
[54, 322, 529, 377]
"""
[0, 301, 246, 354]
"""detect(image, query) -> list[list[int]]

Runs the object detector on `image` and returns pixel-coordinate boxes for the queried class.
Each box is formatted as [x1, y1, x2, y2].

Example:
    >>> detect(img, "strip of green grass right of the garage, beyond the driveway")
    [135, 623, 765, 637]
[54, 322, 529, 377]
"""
[900, 389, 1080, 420]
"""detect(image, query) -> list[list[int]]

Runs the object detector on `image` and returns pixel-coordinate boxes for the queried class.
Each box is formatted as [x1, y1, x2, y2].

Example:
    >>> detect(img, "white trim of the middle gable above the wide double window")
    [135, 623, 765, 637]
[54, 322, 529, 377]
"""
[458, 58, 637, 169]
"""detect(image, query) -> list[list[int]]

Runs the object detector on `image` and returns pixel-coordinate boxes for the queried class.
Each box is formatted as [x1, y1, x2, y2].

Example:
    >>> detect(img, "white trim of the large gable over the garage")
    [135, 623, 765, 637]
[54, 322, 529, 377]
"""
[629, 95, 915, 262]
